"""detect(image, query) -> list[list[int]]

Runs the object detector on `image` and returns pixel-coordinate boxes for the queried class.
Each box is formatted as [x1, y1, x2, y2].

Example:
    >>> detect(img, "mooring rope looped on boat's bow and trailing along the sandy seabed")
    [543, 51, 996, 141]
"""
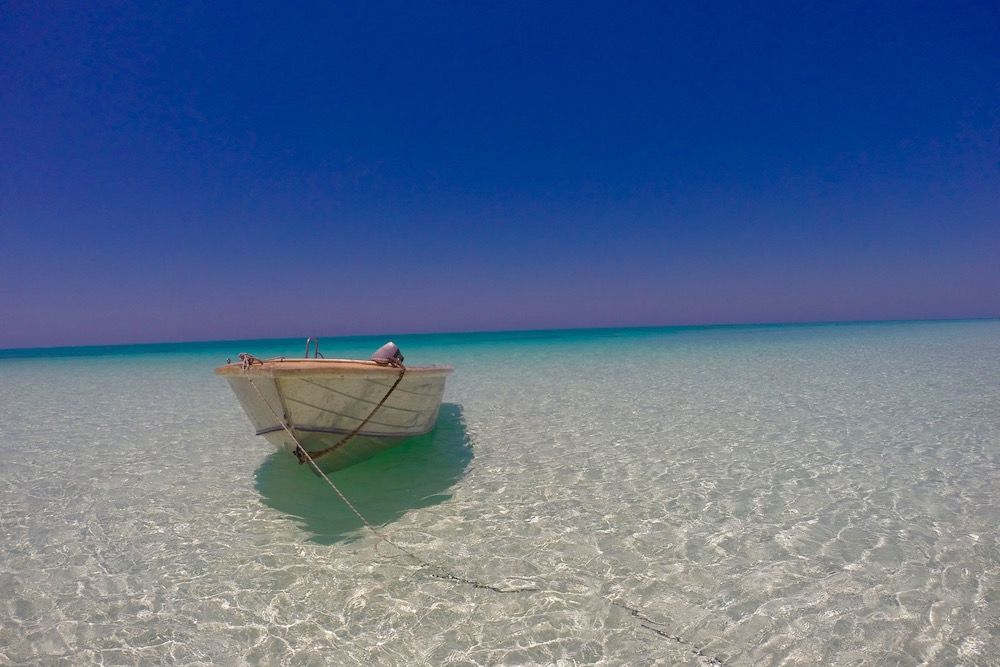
[239, 353, 725, 665]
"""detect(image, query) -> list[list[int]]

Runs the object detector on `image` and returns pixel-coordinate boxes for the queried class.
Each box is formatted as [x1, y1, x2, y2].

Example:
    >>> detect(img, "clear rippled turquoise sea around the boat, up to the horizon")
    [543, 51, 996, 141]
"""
[0, 321, 1000, 665]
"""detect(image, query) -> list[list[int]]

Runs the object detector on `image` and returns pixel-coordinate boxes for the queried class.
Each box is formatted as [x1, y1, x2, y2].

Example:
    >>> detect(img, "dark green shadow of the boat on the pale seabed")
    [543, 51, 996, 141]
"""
[255, 403, 472, 544]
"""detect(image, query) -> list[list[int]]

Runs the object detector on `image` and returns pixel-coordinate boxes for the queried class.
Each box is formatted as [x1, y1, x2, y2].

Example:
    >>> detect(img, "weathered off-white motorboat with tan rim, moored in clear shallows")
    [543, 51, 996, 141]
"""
[221, 341, 453, 471]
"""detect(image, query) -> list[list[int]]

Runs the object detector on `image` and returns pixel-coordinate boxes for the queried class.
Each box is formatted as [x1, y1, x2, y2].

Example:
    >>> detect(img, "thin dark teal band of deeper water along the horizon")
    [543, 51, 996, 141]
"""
[0, 316, 1000, 359]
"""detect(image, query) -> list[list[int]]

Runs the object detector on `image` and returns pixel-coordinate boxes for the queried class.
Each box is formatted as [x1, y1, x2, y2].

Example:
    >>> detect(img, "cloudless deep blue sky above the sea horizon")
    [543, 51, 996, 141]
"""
[0, 1, 1000, 347]
